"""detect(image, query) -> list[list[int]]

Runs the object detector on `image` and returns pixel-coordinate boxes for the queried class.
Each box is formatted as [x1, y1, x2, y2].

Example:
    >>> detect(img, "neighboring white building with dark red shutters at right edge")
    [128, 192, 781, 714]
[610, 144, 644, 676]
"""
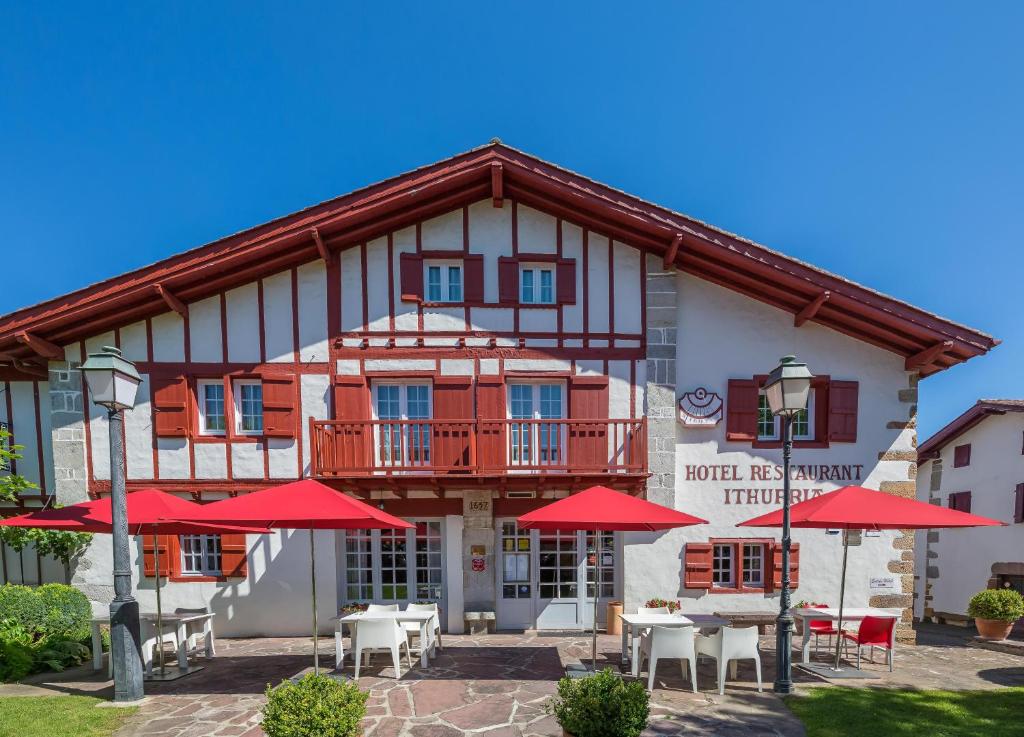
[914, 399, 1024, 632]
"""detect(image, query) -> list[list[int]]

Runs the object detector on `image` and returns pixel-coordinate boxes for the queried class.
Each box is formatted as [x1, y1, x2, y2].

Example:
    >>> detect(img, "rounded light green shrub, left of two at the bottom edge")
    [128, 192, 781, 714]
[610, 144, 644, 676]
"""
[260, 674, 367, 737]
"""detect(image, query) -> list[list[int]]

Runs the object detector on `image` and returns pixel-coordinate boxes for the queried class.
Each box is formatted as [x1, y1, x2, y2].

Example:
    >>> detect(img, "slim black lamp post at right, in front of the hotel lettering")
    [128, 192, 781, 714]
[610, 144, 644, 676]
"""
[765, 355, 814, 694]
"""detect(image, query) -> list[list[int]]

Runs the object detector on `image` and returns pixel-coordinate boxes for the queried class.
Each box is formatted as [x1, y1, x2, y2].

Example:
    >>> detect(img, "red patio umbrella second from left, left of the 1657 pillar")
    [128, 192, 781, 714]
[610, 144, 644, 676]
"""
[178, 479, 416, 674]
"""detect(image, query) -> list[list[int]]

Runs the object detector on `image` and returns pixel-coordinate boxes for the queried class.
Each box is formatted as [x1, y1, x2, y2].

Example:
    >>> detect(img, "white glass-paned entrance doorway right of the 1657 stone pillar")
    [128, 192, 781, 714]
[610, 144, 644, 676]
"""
[496, 519, 620, 630]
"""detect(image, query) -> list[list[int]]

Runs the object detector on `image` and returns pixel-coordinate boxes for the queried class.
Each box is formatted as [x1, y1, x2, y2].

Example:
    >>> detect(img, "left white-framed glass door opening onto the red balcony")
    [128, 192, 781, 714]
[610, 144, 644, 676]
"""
[373, 382, 432, 466]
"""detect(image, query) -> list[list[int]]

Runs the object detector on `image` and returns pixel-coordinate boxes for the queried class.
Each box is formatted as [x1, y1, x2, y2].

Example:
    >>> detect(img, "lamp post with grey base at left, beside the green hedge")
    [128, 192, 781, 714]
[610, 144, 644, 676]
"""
[82, 346, 142, 701]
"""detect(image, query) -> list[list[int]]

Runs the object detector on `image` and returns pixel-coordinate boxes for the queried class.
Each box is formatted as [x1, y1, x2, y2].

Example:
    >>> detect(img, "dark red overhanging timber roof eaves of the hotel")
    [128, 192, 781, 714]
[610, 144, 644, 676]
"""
[0, 141, 998, 376]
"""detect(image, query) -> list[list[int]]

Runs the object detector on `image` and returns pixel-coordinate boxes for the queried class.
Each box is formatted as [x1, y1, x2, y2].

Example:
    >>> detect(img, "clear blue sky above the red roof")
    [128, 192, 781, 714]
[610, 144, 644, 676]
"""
[0, 2, 1024, 436]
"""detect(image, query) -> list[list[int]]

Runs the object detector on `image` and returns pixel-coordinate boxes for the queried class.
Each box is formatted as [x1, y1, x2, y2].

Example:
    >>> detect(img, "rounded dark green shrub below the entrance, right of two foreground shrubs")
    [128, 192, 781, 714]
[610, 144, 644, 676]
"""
[547, 668, 650, 737]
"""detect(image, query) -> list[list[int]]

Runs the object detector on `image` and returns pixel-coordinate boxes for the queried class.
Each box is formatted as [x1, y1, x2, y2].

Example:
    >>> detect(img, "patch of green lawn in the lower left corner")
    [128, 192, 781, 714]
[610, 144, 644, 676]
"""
[0, 696, 135, 737]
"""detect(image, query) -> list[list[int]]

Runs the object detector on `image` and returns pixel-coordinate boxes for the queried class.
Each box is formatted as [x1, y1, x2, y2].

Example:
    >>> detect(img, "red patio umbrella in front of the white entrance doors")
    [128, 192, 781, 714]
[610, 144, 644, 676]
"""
[516, 486, 708, 670]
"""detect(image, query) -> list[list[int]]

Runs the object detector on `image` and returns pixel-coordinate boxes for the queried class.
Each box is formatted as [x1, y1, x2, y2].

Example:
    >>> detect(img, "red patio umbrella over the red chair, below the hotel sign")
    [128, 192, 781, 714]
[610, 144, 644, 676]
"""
[736, 486, 1006, 670]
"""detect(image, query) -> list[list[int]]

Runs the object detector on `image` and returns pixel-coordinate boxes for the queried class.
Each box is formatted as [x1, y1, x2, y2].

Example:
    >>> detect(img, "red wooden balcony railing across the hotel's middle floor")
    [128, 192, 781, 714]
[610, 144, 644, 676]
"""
[309, 418, 647, 477]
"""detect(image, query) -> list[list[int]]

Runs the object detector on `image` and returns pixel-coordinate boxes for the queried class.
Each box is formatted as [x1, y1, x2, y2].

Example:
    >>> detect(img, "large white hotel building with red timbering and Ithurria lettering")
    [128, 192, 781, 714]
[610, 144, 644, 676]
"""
[0, 143, 995, 635]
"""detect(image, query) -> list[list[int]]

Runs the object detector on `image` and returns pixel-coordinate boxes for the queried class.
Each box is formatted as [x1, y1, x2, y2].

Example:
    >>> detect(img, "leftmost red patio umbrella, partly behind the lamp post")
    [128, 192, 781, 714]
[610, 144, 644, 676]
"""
[0, 488, 269, 677]
